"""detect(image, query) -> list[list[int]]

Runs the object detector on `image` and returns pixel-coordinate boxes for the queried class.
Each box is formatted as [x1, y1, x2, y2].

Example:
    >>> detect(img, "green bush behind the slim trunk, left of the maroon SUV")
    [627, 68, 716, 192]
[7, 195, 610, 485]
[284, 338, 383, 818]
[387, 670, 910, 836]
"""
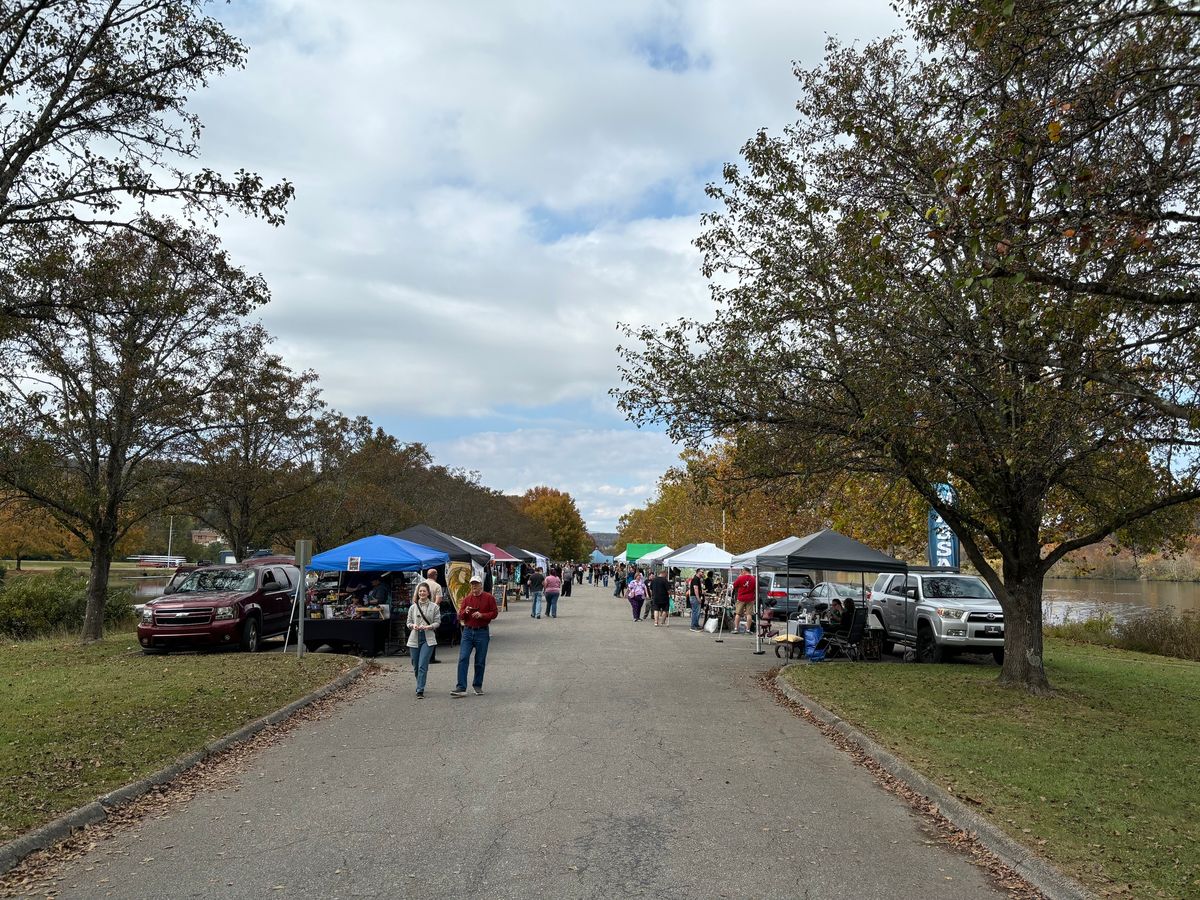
[0, 569, 133, 638]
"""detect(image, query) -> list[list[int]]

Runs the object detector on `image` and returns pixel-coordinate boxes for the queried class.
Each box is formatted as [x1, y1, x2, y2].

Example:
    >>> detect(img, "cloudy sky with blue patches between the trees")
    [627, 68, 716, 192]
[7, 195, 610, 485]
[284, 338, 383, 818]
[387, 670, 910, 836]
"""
[193, 0, 895, 530]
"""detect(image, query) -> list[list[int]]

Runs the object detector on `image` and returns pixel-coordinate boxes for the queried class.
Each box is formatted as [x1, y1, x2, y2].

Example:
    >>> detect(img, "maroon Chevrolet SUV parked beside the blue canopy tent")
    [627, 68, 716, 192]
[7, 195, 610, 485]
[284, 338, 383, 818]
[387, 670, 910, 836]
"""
[138, 557, 300, 653]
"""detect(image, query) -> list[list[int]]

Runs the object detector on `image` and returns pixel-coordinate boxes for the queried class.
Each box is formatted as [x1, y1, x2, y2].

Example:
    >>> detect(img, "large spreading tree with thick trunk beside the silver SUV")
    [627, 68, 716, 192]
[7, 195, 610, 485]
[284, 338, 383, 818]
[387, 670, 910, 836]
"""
[622, 0, 1200, 692]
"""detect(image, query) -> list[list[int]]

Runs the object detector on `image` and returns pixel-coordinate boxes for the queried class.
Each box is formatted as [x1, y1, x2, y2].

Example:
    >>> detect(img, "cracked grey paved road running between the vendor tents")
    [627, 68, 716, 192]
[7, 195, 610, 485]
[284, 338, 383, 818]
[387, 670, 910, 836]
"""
[46, 586, 1001, 900]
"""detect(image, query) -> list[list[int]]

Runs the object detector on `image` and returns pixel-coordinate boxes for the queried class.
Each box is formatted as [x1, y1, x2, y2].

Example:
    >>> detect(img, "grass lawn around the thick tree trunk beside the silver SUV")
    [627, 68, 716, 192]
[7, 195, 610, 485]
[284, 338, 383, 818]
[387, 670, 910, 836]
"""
[787, 640, 1200, 898]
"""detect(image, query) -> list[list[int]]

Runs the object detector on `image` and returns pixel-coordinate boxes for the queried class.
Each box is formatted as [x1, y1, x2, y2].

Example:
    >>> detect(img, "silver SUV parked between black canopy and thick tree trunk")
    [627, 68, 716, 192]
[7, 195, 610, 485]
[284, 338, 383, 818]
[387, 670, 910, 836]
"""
[866, 570, 1004, 664]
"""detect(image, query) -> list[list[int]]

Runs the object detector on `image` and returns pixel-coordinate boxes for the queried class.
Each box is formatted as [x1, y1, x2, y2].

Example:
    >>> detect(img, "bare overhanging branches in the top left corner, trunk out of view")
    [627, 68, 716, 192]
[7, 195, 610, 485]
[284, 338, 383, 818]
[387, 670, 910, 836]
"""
[0, 0, 293, 338]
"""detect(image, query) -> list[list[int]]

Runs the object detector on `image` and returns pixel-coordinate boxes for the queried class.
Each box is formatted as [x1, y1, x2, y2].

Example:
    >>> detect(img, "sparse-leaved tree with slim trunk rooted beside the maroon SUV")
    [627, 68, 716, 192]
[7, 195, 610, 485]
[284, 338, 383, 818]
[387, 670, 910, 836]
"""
[0, 220, 266, 640]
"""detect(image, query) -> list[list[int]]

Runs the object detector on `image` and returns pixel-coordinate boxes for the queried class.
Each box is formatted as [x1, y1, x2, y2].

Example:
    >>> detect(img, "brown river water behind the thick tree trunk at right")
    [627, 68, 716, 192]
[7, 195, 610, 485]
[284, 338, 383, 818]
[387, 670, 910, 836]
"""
[1042, 578, 1200, 624]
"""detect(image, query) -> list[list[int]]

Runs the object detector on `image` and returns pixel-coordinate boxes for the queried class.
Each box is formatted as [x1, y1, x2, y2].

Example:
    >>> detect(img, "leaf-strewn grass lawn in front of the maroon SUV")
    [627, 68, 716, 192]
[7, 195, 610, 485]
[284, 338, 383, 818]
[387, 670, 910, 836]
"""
[0, 632, 353, 842]
